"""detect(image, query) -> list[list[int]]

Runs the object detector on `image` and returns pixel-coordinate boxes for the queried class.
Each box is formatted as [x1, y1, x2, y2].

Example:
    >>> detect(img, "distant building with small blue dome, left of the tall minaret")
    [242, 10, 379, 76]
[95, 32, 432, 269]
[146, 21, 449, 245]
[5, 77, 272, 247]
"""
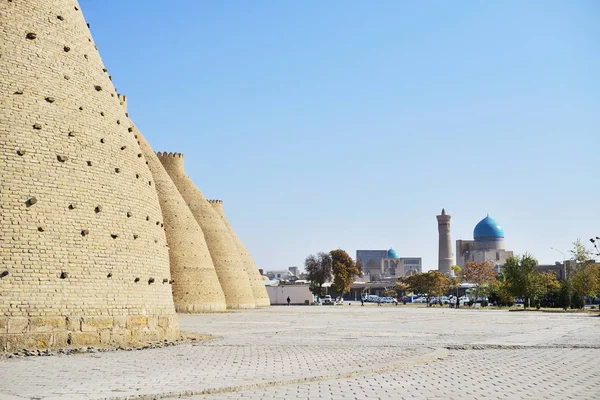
[356, 249, 423, 282]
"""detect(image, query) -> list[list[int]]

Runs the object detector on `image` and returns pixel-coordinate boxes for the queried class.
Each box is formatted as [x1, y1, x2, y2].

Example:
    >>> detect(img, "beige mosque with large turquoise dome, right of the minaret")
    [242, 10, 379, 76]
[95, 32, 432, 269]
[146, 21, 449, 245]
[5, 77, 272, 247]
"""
[456, 215, 513, 271]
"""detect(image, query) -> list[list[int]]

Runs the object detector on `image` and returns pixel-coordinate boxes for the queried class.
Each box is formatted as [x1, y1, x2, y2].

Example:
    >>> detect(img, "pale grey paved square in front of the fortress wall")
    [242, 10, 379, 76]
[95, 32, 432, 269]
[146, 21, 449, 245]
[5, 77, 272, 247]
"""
[0, 304, 600, 400]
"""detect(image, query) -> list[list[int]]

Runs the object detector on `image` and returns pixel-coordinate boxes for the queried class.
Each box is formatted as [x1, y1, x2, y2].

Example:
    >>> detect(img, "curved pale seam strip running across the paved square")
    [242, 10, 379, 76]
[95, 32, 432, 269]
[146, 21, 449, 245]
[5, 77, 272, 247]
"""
[101, 348, 450, 400]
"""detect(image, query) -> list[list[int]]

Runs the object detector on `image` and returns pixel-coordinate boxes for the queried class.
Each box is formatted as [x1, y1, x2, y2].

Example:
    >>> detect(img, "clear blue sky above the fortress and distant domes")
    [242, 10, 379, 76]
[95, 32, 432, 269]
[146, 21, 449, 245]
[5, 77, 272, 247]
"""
[80, 0, 600, 270]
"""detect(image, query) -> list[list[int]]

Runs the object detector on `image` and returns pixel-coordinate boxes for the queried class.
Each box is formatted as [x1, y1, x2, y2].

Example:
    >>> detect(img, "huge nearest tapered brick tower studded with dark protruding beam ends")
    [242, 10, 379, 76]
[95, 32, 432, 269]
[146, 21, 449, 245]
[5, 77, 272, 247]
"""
[0, 0, 179, 351]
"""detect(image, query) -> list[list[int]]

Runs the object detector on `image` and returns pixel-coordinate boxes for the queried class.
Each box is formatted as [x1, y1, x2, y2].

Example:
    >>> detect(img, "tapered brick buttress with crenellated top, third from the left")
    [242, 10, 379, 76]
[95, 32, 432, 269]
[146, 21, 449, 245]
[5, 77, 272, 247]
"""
[158, 153, 256, 308]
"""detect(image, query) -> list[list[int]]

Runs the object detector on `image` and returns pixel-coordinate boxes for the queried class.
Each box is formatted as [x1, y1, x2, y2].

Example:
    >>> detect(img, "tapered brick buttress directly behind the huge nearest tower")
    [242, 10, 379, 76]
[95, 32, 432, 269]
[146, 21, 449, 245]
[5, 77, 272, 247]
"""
[133, 127, 226, 312]
